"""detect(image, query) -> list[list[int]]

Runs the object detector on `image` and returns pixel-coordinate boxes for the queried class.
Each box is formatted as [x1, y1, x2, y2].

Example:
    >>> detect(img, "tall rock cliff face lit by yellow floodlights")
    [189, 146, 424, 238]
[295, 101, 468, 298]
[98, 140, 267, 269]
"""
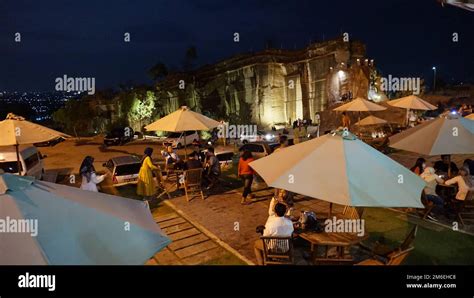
[159, 40, 371, 127]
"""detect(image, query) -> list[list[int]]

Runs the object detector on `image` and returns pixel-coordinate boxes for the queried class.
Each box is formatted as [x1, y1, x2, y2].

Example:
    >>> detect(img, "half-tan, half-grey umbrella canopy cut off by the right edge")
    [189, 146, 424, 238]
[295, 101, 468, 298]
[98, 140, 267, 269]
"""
[390, 115, 474, 155]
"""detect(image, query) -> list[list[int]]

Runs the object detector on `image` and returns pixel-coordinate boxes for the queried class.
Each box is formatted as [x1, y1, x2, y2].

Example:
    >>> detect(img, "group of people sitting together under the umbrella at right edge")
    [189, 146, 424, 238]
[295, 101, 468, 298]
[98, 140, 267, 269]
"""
[411, 155, 474, 220]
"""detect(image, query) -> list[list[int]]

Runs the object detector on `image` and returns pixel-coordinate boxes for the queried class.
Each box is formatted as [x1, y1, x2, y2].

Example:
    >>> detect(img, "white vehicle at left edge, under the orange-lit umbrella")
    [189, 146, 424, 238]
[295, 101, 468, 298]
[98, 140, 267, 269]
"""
[0, 145, 46, 179]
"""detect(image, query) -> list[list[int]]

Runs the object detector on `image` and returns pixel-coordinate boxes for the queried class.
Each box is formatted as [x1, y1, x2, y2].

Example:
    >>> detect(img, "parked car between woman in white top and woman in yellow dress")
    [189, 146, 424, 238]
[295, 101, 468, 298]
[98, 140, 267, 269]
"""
[103, 155, 142, 186]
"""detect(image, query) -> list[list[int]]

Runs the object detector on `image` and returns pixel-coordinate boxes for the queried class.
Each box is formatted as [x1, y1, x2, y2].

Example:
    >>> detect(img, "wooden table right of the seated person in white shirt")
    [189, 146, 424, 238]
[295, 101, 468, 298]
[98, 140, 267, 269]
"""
[298, 231, 369, 262]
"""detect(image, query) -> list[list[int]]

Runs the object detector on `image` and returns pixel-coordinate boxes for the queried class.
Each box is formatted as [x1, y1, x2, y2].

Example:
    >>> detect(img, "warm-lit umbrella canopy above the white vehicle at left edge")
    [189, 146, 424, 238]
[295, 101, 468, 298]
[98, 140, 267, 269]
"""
[0, 114, 70, 146]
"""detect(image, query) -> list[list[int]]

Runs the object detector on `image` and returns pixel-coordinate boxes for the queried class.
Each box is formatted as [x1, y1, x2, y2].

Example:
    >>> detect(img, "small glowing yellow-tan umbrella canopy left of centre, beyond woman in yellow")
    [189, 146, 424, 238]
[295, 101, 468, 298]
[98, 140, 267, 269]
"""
[145, 107, 220, 132]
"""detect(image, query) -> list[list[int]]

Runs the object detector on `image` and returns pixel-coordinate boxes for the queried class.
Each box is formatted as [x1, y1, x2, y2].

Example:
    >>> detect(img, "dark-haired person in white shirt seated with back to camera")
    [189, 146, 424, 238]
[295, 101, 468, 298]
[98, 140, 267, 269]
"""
[254, 203, 294, 265]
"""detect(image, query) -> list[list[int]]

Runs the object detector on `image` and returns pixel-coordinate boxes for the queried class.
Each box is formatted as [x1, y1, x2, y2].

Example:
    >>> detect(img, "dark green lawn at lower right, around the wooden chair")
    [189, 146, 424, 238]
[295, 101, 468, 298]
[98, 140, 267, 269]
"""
[363, 208, 474, 265]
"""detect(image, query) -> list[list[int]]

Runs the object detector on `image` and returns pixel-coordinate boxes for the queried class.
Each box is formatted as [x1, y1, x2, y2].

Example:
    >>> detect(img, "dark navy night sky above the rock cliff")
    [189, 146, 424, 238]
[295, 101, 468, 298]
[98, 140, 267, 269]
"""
[0, 0, 474, 91]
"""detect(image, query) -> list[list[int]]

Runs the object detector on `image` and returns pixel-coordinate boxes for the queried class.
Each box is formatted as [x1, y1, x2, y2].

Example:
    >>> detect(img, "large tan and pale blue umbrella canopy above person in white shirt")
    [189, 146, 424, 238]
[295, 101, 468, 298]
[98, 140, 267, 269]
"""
[250, 132, 425, 208]
